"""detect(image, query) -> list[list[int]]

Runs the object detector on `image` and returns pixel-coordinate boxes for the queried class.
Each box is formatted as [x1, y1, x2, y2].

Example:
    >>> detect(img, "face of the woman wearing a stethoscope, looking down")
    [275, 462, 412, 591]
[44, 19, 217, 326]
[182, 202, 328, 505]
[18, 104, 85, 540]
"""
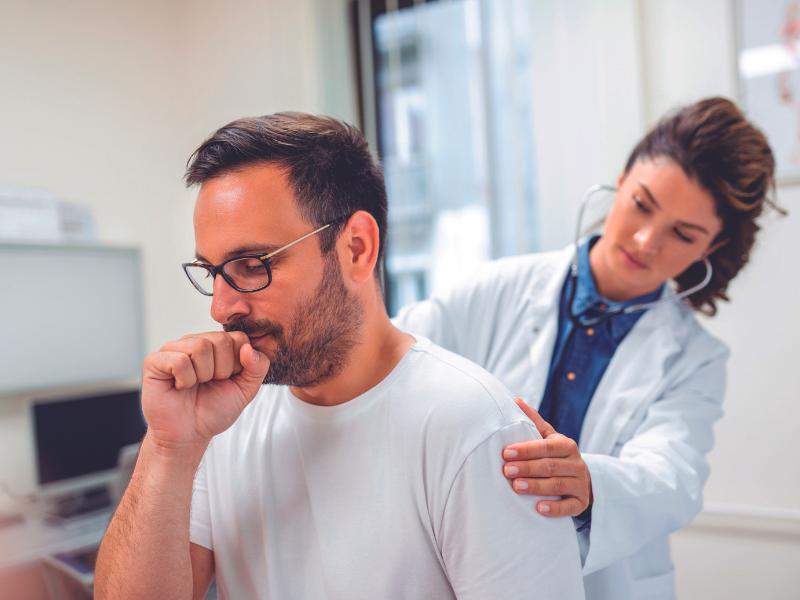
[590, 157, 722, 301]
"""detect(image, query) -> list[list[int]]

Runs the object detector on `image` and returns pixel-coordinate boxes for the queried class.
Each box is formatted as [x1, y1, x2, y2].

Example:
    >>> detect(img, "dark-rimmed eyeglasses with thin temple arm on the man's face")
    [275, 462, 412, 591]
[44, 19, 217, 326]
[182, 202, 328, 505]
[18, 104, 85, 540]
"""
[181, 217, 347, 296]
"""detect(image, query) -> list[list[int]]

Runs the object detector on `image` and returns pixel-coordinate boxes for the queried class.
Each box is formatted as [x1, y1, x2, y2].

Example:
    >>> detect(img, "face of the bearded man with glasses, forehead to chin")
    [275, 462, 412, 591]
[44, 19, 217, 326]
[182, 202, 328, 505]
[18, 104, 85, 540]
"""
[194, 164, 362, 387]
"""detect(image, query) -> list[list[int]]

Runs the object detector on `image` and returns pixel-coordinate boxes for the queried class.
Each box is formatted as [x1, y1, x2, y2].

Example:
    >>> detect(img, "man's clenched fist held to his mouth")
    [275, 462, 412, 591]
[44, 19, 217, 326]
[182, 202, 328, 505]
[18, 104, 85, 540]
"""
[142, 331, 269, 450]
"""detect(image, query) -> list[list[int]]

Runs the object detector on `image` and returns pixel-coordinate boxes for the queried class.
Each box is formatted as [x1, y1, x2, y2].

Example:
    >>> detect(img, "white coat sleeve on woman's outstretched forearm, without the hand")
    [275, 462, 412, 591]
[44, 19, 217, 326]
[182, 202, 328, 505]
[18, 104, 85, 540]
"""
[583, 356, 726, 574]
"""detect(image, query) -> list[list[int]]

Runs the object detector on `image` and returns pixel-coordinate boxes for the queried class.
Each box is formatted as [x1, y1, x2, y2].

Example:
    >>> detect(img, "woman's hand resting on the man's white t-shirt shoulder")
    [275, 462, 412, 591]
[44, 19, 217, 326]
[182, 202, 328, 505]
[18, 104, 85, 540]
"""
[503, 398, 592, 517]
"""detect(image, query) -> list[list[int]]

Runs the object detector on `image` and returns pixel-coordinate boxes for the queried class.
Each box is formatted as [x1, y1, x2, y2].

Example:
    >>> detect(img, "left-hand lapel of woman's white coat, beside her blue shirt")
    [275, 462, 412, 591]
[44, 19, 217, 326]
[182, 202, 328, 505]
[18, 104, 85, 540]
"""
[525, 246, 574, 410]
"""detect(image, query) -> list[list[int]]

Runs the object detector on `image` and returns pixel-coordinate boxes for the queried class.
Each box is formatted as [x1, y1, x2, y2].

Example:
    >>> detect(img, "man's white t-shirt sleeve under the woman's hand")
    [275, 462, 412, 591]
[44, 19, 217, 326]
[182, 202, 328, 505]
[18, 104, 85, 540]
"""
[438, 422, 584, 600]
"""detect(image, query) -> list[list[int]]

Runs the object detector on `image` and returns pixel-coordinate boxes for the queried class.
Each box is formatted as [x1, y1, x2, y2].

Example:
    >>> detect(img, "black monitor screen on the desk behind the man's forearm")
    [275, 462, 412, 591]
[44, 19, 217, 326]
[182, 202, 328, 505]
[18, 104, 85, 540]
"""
[33, 390, 145, 485]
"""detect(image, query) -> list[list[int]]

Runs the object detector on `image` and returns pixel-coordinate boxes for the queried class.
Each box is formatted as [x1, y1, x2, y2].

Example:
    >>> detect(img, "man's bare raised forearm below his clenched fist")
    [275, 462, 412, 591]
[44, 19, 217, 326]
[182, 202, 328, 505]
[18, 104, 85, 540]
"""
[95, 434, 205, 600]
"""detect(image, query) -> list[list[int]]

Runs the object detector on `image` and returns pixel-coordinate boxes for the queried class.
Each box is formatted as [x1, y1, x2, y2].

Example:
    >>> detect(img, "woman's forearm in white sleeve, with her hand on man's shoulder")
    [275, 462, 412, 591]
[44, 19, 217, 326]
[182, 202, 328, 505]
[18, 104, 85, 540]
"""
[503, 354, 727, 574]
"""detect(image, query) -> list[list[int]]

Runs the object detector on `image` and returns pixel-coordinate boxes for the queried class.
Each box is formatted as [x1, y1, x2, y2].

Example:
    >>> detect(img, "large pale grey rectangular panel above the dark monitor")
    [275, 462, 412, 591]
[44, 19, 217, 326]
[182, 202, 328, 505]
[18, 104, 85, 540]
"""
[0, 243, 145, 396]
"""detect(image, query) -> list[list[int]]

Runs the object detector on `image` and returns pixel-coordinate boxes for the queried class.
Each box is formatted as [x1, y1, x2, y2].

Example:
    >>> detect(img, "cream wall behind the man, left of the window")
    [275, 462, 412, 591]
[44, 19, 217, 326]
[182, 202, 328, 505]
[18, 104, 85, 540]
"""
[0, 0, 330, 496]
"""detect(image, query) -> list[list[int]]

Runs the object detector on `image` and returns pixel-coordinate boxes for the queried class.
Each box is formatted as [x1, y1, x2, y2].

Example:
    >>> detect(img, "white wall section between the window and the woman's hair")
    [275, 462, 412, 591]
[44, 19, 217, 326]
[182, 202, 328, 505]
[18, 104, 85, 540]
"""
[530, 0, 644, 250]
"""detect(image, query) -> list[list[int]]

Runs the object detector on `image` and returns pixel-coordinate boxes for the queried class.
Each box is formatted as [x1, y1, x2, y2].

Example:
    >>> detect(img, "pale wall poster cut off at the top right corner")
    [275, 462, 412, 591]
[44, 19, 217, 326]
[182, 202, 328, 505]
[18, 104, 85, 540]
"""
[737, 0, 800, 183]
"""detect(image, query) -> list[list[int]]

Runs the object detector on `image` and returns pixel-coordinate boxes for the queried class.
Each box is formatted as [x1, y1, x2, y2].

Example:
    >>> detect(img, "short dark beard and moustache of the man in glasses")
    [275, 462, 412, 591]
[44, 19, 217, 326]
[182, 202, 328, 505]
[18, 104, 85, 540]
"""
[223, 253, 364, 387]
